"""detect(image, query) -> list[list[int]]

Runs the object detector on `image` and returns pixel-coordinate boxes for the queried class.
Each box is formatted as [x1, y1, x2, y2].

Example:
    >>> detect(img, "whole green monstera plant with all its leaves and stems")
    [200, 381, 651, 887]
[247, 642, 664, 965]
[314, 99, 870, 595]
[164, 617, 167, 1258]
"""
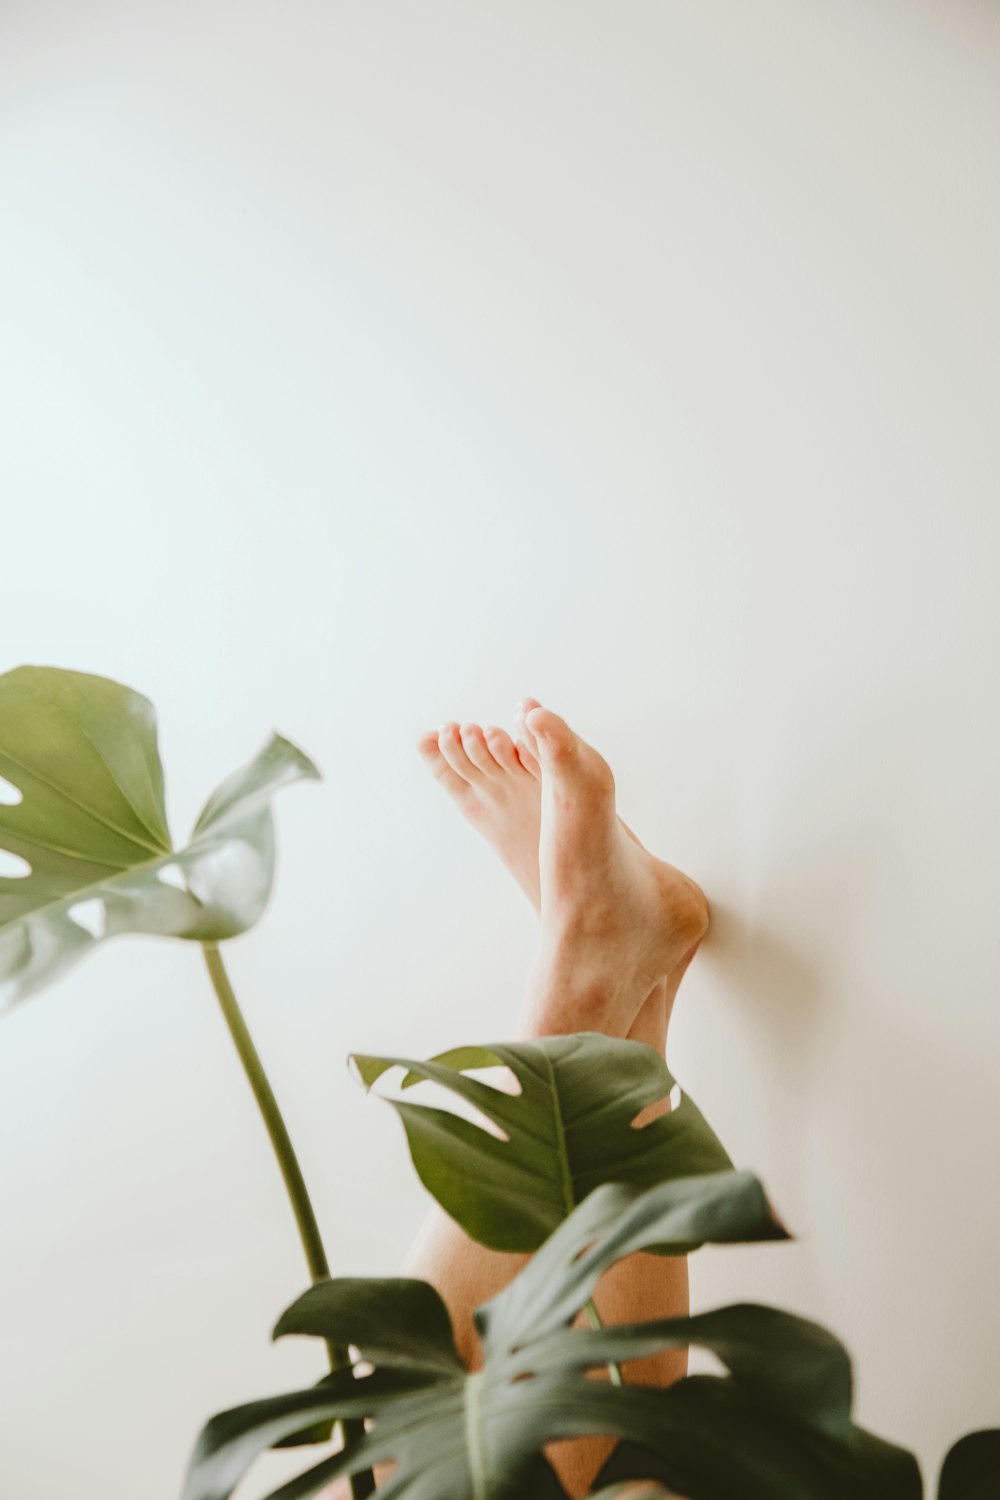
[0, 668, 1000, 1500]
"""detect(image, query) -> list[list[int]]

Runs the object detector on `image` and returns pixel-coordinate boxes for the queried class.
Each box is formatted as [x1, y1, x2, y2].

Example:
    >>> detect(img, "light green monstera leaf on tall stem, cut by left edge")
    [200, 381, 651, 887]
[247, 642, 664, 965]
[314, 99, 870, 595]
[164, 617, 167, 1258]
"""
[0, 668, 319, 1010]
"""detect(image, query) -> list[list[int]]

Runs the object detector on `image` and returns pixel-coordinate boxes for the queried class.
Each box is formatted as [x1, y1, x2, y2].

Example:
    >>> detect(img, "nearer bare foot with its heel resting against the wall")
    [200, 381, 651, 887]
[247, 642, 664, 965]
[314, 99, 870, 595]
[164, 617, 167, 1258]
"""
[523, 705, 708, 1037]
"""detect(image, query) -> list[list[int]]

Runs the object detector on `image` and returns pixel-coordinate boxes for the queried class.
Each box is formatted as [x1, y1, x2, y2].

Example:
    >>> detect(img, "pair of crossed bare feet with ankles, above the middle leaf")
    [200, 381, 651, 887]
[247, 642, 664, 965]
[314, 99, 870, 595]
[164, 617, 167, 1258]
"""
[420, 698, 708, 1041]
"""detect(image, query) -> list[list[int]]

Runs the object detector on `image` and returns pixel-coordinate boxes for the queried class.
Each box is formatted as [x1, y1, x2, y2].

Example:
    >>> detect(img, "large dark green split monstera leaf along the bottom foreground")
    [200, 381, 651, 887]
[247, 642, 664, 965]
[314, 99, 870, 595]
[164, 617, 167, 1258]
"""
[184, 1173, 919, 1500]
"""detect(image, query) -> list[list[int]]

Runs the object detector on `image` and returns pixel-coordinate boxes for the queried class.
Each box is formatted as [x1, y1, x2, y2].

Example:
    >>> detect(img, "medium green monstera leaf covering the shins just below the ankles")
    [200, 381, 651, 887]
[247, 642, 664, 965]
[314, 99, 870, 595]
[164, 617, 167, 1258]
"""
[352, 1032, 732, 1251]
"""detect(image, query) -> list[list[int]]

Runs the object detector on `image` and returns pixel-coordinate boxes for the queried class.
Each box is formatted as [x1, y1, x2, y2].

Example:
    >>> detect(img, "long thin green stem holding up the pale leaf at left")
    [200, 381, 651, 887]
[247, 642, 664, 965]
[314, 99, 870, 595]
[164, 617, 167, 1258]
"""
[201, 944, 375, 1500]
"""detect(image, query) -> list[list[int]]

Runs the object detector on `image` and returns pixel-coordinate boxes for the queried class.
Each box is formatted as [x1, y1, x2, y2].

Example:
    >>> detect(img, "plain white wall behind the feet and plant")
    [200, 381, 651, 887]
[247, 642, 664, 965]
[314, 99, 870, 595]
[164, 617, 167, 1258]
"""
[0, 0, 1000, 1500]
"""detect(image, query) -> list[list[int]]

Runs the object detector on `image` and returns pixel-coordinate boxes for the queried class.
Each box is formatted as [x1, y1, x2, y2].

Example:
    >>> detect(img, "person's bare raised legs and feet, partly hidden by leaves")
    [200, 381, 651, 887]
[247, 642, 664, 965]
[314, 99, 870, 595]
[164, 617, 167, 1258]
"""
[325, 698, 709, 1500]
